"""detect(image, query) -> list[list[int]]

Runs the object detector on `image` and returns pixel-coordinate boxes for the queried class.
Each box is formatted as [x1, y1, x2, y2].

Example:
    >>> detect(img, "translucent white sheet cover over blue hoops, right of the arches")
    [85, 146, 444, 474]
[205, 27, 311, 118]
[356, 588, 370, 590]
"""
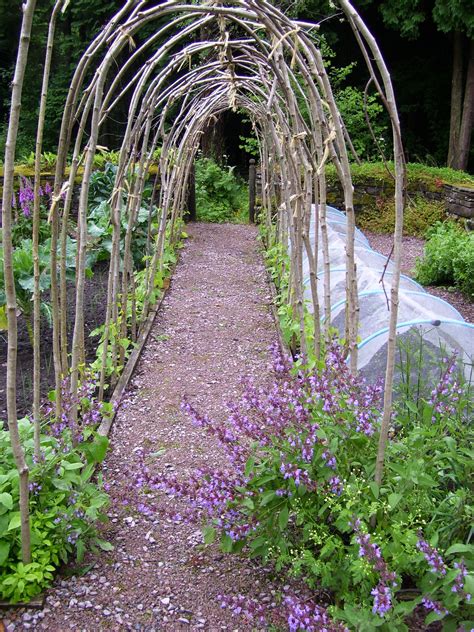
[303, 207, 474, 387]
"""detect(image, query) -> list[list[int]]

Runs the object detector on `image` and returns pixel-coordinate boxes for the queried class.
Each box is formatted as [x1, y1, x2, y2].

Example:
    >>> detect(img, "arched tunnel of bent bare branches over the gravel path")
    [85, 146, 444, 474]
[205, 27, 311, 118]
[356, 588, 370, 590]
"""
[3, 0, 474, 624]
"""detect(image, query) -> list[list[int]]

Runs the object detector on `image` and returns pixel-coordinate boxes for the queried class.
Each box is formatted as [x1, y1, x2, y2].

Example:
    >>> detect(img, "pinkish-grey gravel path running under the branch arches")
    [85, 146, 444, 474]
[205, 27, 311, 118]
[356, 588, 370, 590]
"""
[6, 224, 276, 632]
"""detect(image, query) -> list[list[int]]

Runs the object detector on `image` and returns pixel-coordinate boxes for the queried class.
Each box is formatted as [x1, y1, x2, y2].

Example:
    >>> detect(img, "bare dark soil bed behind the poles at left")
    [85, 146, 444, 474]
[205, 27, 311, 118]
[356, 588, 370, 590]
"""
[0, 262, 108, 421]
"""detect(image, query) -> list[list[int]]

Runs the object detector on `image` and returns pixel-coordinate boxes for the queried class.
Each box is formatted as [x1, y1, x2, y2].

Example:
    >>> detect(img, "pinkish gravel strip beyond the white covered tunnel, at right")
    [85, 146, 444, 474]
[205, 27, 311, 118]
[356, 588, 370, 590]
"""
[364, 231, 474, 323]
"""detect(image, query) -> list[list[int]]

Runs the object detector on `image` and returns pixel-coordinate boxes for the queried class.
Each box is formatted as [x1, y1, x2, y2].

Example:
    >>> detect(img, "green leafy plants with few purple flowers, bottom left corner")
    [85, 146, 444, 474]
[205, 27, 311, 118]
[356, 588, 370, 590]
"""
[0, 381, 112, 603]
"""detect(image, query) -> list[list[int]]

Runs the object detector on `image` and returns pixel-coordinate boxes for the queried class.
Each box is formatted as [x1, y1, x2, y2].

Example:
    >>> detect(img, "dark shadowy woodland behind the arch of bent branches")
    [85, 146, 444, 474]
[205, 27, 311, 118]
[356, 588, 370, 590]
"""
[0, 0, 474, 171]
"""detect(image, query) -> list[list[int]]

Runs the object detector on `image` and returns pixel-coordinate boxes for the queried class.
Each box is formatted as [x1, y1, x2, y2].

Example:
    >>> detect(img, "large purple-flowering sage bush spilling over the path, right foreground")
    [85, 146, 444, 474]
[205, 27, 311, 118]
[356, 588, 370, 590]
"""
[147, 345, 474, 631]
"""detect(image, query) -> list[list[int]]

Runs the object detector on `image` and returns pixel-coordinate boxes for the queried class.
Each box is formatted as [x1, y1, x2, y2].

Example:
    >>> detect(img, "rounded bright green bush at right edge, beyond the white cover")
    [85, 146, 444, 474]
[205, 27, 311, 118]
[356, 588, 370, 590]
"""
[416, 222, 474, 298]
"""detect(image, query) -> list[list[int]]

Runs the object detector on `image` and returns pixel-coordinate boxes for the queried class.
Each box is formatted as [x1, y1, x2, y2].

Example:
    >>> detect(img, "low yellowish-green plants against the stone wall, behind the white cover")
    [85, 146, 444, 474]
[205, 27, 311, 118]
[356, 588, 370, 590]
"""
[357, 195, 446, 237]
